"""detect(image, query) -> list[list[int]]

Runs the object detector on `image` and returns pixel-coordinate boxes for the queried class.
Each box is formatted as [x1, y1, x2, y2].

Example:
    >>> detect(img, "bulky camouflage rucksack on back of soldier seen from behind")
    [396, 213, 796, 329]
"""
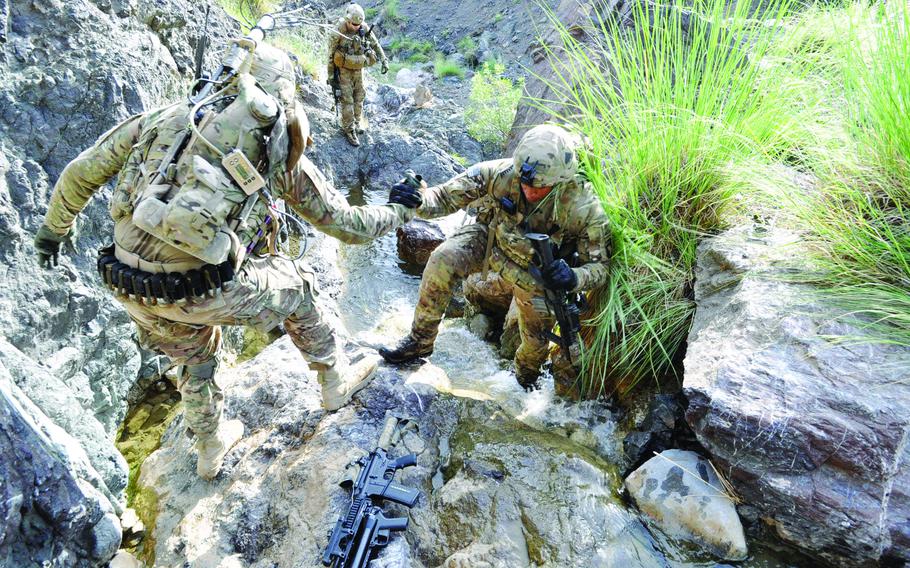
[131, 45, 296, 264]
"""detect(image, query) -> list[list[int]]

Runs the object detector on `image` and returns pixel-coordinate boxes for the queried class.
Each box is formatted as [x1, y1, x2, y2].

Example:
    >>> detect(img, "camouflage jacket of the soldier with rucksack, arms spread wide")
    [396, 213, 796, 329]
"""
[45, 103, 413, 264]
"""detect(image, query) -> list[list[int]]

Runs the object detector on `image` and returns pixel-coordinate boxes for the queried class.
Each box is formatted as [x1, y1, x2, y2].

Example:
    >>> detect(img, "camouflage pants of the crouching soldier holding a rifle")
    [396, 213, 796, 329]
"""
[411, 223, 574, 378]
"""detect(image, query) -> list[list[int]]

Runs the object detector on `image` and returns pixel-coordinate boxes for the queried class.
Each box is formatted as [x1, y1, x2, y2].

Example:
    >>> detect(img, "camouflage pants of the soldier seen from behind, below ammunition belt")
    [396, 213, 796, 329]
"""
[118, 256, 338, 436]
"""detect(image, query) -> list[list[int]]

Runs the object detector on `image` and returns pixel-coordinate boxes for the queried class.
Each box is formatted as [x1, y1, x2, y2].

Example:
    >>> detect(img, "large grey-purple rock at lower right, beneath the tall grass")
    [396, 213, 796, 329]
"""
[684, 226, 910, 566]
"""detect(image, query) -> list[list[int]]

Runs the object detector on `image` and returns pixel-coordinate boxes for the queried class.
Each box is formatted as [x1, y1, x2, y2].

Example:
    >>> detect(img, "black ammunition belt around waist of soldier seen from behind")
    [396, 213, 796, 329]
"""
[98, 247, 235, 304]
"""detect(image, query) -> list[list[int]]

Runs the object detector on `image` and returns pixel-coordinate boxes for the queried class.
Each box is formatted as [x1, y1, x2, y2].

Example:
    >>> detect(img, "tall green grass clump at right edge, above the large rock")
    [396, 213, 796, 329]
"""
[791, 2, 910, 347]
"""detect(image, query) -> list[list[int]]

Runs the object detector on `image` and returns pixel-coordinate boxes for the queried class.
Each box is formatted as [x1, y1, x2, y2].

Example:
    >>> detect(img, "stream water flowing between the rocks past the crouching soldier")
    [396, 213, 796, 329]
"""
[338, 188, 798, 568]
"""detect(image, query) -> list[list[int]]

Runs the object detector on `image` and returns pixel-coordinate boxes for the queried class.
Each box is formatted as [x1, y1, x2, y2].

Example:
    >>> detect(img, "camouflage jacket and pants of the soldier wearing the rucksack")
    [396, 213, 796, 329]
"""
[45, 48, 413, 436]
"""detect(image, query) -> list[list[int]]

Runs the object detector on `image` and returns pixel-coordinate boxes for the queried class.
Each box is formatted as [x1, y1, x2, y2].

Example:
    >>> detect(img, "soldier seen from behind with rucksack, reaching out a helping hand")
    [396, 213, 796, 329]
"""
[35, 44, 413, 479]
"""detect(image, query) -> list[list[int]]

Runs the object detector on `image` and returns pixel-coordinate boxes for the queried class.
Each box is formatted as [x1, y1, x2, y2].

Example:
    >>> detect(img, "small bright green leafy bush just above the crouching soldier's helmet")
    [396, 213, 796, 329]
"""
[464, 62, 522, 148]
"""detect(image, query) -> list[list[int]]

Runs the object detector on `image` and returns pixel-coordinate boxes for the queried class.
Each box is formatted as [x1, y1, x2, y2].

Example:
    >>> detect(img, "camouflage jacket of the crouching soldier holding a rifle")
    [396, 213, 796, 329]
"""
[417, 159, 612, 291]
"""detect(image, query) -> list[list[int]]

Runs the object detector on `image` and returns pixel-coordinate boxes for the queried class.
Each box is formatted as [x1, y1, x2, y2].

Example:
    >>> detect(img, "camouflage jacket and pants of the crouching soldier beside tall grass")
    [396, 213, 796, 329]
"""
[400, 129, 610, 386]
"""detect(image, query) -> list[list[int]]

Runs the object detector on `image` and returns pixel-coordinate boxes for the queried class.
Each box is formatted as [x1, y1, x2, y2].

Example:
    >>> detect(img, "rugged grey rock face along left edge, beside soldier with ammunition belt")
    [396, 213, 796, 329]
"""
[0, 0, 239, 566]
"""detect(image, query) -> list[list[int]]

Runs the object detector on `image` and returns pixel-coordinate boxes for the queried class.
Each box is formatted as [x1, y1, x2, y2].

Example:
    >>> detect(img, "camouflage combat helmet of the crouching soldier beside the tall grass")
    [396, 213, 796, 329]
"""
[513, 124, 580, 187]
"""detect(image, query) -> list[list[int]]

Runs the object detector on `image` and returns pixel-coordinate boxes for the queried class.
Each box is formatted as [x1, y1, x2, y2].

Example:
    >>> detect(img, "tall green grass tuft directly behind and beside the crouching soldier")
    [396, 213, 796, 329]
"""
[538, 0, 806, 396]
